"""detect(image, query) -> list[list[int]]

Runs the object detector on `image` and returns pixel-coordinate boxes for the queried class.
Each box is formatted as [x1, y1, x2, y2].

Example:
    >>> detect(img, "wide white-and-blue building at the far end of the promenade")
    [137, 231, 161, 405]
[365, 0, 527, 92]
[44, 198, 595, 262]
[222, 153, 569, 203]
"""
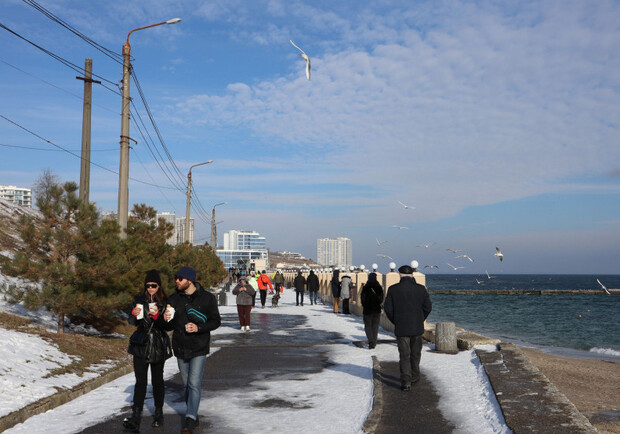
[215, 230, 269, 269]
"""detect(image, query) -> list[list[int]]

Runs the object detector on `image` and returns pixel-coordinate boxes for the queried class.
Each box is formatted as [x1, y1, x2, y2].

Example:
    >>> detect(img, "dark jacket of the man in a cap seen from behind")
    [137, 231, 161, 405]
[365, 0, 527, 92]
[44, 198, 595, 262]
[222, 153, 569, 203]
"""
[383, 276, 433, 336]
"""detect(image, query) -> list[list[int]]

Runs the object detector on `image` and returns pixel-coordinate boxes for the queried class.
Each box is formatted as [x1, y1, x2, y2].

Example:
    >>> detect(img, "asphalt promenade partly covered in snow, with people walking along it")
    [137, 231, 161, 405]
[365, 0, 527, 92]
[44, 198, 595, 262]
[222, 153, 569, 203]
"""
[6, 289, 593, 434]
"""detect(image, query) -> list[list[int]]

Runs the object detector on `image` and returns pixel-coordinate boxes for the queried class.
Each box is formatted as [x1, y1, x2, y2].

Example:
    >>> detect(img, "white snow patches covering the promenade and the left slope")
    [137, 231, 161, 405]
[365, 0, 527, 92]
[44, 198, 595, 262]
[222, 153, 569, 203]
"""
[0, 290, 510, 434]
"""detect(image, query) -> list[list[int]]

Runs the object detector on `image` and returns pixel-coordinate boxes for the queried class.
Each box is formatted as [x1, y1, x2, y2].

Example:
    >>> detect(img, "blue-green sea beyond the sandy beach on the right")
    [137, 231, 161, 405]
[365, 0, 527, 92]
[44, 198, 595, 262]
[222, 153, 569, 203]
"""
[426, 273, 620, 362]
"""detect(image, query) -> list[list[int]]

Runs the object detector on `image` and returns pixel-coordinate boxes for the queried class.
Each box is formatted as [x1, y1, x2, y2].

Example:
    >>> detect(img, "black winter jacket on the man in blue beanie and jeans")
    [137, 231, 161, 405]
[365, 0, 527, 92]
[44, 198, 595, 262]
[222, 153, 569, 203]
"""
[166, 283, 222, 360]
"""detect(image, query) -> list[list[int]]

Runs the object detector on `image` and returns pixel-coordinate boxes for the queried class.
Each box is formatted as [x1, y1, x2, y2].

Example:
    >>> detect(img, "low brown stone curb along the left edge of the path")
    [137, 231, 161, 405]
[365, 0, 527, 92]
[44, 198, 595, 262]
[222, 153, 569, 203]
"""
[0, 361, 133, 432]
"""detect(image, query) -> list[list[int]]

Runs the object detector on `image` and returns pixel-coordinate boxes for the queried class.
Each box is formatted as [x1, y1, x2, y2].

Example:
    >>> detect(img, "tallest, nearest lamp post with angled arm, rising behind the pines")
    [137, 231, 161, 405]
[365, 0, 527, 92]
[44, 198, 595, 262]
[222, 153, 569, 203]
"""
[118, 18, 181, 239]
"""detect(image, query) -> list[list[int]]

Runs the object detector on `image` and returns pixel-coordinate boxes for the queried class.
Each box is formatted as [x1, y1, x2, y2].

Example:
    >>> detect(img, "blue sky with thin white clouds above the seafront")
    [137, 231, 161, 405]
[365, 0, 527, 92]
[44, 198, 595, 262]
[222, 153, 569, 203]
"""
[0, 0, 620, 274]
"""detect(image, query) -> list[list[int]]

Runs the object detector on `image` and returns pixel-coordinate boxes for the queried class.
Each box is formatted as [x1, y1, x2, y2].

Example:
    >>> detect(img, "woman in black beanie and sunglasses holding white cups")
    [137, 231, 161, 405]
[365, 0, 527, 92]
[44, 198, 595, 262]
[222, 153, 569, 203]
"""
[123, 270, 172, 432]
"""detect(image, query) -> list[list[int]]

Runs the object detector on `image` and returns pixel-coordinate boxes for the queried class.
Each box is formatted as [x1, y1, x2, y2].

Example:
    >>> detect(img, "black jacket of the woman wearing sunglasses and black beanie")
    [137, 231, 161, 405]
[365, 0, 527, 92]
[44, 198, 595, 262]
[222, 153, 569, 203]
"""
[127, 294, 172, 363]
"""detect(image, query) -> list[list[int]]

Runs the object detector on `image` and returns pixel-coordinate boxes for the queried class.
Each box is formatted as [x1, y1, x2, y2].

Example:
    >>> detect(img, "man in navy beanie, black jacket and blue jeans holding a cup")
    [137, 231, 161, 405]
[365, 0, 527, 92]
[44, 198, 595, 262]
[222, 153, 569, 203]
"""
[164, 267, 222, 434]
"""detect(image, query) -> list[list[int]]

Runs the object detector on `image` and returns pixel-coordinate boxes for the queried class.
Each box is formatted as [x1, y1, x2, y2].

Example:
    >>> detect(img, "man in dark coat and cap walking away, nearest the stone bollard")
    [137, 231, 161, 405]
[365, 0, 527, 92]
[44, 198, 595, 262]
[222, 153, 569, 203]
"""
[383, 264, 432, 391]
